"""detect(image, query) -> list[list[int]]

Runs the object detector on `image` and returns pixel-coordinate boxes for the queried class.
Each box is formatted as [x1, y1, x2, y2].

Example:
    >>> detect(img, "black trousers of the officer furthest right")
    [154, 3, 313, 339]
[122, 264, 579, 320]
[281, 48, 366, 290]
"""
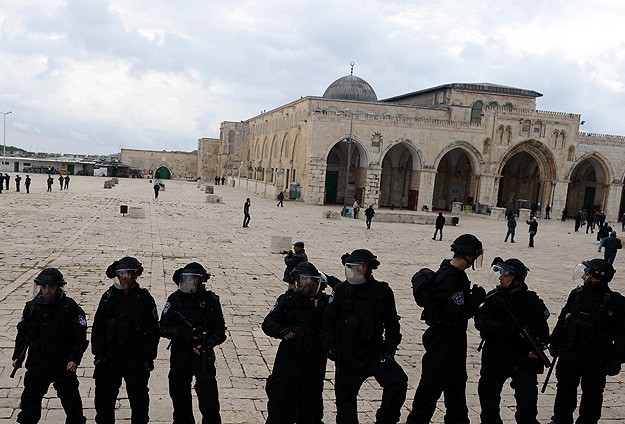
[551, 359, 606, 424]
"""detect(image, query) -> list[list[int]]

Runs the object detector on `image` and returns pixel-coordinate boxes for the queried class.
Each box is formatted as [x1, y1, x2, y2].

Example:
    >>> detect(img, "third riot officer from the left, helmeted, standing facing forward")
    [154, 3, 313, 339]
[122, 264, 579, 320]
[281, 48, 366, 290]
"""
[160, 262, 226, 424]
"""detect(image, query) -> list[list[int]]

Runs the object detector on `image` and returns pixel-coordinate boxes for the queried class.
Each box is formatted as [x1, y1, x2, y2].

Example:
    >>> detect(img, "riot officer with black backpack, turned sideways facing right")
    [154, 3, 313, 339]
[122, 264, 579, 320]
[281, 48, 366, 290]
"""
[406, 234, 486, 424]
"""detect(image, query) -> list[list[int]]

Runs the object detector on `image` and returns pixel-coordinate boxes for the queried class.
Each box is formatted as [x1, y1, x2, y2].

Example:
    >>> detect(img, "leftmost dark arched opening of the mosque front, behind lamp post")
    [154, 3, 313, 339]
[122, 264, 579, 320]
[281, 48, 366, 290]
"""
[324, 139, 367, 206]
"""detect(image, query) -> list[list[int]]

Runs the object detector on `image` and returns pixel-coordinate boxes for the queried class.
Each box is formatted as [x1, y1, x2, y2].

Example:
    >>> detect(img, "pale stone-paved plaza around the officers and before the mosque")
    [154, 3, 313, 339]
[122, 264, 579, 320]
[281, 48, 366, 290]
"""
[0, 175, 625, 424]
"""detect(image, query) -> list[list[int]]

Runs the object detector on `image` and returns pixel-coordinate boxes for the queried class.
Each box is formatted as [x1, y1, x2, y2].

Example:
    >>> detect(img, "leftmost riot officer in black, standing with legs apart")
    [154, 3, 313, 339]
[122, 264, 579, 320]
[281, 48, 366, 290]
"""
[13, 268, 88, 424]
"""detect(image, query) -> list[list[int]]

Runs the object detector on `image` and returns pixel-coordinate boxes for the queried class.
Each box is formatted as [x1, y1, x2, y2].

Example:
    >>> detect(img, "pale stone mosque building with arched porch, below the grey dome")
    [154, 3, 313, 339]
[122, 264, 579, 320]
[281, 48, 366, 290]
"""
[213, 77, 625, 220]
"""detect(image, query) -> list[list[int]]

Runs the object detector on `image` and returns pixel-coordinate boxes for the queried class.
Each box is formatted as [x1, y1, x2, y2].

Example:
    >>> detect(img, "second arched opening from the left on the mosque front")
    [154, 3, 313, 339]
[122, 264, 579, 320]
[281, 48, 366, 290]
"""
[379, 143, 421, 210]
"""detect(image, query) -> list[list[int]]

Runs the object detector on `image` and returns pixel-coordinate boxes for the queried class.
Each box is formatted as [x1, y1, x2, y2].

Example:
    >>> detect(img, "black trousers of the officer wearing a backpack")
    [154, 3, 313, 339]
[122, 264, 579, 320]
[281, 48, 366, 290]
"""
[407, 327, 469, 424]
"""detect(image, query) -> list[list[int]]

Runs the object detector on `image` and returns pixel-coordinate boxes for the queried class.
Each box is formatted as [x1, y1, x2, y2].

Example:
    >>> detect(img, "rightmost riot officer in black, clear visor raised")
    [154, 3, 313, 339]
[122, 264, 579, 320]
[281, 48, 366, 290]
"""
[549, 259, 625, 424]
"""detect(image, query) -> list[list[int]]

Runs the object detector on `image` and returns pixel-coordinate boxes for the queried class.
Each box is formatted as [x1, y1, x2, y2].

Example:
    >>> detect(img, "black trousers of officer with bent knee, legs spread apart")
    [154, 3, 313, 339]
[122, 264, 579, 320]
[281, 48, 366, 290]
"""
[334, 358, 408, 424]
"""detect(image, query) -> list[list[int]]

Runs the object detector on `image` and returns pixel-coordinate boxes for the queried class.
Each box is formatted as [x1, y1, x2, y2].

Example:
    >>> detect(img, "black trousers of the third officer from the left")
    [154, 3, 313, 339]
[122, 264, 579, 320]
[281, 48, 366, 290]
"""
[169, 350, 221, 424]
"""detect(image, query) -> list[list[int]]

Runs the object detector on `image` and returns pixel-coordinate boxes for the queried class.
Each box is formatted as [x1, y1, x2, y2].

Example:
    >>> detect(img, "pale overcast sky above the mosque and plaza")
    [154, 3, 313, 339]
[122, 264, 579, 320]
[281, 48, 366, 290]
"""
[0, 0, 625, 154]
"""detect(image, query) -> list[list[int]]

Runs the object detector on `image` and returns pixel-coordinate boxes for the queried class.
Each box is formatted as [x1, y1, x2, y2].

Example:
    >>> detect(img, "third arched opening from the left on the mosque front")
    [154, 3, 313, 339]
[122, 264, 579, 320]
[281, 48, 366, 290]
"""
[432, 147, 474, 210]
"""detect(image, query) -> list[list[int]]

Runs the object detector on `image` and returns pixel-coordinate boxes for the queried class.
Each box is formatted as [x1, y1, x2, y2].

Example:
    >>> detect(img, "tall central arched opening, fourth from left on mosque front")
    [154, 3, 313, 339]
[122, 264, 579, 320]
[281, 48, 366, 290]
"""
[497, 152, 541, 212]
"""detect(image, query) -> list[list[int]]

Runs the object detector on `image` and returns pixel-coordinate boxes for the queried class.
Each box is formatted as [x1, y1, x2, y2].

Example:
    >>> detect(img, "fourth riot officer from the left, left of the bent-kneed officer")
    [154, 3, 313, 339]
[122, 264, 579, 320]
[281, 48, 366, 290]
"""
[262, 262, 328, 424]
